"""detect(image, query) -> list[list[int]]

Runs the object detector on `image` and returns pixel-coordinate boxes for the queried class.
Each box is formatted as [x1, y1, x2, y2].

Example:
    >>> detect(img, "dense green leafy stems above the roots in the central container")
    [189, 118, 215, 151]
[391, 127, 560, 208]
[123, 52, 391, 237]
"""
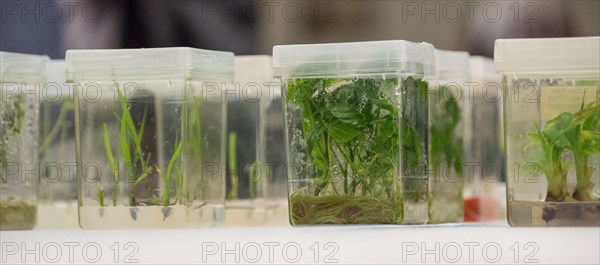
[286, 78, 400, 198]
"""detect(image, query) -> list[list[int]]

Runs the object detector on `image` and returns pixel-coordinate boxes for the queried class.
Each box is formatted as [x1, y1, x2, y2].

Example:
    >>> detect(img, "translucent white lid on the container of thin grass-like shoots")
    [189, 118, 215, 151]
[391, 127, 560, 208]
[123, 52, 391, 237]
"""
[66, 47, 233, 81]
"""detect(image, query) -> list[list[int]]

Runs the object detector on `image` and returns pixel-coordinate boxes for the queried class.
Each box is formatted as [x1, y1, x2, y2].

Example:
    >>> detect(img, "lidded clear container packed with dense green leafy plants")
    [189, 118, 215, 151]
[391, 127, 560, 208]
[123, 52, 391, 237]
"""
[273, 41, 435, 225]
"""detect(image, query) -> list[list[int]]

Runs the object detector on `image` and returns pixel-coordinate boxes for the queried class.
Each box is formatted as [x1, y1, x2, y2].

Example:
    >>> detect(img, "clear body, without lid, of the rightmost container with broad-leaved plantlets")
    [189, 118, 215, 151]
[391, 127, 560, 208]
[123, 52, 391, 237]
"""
[504, 75, 600, 226]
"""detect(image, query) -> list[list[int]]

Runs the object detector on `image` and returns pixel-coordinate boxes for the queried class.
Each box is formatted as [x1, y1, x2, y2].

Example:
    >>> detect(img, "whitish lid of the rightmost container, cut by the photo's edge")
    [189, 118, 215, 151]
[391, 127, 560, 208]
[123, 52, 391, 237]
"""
[494, 37, 600, 72]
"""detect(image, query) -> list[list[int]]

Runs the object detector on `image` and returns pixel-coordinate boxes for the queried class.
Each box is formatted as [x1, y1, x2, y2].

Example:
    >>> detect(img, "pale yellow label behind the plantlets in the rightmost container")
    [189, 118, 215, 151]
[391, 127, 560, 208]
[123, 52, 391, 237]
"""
[540, 86, 598, 120]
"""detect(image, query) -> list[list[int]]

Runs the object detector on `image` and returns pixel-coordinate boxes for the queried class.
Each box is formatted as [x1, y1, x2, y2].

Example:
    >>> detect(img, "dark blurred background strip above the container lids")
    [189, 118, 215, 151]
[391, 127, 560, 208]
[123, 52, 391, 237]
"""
[0, 0, 600, 59]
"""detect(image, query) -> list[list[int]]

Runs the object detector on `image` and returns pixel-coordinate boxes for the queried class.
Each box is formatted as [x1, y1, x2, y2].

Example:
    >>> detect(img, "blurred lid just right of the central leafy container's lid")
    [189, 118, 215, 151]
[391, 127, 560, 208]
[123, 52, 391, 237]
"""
[435, 49, 471, 82]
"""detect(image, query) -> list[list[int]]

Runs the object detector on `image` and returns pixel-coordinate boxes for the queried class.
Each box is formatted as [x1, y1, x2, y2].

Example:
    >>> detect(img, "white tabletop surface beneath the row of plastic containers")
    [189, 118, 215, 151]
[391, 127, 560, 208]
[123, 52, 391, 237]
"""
[0, 222, 600, 264]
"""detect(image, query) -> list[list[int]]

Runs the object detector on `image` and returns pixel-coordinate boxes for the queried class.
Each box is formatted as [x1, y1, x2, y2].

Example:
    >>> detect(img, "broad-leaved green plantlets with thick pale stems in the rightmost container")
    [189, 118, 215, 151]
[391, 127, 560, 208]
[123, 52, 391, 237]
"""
[529, 101, 600, 201]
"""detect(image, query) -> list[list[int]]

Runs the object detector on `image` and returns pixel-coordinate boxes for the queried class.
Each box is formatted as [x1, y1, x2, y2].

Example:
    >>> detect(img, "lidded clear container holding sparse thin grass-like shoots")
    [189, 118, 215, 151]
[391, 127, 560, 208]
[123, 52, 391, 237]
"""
[66, 48, 233, 229]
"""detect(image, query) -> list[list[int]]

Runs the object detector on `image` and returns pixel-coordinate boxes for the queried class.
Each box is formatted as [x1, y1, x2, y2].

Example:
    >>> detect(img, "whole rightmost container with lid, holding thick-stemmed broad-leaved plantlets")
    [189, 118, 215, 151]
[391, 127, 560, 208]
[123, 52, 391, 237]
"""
[495, 37, 600, 226]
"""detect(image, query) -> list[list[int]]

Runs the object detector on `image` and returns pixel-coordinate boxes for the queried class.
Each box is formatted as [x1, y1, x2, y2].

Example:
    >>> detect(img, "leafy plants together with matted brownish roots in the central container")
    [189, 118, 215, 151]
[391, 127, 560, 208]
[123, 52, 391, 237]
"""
[286, 77, 427, 224]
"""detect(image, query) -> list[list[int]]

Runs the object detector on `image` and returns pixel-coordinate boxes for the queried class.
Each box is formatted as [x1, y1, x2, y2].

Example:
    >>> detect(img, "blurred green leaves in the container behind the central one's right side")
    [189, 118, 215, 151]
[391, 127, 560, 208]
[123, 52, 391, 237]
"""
[429, 86, 464, 175]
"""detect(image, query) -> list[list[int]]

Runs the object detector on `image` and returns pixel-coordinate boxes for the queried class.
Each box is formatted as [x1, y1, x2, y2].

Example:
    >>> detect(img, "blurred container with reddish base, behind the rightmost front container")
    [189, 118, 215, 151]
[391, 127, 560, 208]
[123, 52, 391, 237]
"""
[464, 56, 506, 222]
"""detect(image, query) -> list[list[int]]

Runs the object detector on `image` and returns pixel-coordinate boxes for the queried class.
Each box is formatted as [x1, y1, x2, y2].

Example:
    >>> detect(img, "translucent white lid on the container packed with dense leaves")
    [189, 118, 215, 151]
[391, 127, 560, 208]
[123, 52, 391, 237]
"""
[273, 40, 435, 77]
